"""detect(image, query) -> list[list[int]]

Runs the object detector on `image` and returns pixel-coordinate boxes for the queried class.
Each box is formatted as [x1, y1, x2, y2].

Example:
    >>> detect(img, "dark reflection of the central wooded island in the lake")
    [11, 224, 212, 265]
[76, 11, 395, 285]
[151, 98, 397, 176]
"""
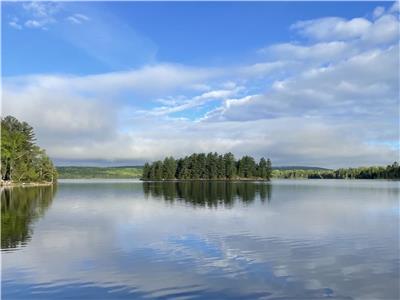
[143, 181, 271, 207]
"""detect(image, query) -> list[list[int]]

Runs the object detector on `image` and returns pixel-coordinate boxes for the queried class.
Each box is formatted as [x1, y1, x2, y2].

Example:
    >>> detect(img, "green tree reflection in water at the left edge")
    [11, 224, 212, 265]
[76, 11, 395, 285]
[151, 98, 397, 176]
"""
[1, 186, 56, 250]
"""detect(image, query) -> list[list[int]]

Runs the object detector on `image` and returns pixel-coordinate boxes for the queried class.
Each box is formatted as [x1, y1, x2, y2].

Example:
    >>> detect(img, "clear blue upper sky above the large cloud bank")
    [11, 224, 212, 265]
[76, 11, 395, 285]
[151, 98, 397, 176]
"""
[2, 2, 391, 76]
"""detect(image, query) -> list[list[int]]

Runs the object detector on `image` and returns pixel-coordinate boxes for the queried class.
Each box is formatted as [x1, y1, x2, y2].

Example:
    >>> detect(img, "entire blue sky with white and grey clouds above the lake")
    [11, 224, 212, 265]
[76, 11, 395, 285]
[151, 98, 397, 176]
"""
[1, 2, 400, 168]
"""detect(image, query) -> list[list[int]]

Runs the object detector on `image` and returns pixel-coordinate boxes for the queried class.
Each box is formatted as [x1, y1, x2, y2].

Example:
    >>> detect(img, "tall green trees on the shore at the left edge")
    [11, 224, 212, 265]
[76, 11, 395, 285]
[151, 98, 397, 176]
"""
[0, 116, 57, 182]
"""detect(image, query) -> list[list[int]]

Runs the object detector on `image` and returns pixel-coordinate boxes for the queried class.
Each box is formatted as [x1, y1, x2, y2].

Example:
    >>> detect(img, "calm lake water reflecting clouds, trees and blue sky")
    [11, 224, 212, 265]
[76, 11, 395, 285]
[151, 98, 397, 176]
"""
[1, 180, 400, 299]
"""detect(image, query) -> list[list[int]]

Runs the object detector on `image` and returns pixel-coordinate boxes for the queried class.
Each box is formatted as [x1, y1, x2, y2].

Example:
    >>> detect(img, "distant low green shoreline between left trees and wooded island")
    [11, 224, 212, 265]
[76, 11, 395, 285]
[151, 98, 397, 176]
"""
[57, 165, 142, 179]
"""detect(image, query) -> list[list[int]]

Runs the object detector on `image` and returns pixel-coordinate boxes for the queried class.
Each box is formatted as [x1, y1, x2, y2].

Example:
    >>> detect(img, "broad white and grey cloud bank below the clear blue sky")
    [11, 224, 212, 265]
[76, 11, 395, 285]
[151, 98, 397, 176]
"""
[2, 4, 399, 167]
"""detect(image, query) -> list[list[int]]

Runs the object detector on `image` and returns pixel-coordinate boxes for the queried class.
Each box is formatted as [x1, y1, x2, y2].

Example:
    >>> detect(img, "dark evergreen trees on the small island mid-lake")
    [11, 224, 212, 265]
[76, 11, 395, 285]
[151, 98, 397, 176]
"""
[142, 152, 272, 180]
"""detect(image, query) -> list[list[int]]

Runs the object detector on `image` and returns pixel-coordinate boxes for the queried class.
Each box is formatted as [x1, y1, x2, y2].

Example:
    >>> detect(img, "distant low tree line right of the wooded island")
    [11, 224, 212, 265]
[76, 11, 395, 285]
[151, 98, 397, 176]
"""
[272, 162, 400, 179]
